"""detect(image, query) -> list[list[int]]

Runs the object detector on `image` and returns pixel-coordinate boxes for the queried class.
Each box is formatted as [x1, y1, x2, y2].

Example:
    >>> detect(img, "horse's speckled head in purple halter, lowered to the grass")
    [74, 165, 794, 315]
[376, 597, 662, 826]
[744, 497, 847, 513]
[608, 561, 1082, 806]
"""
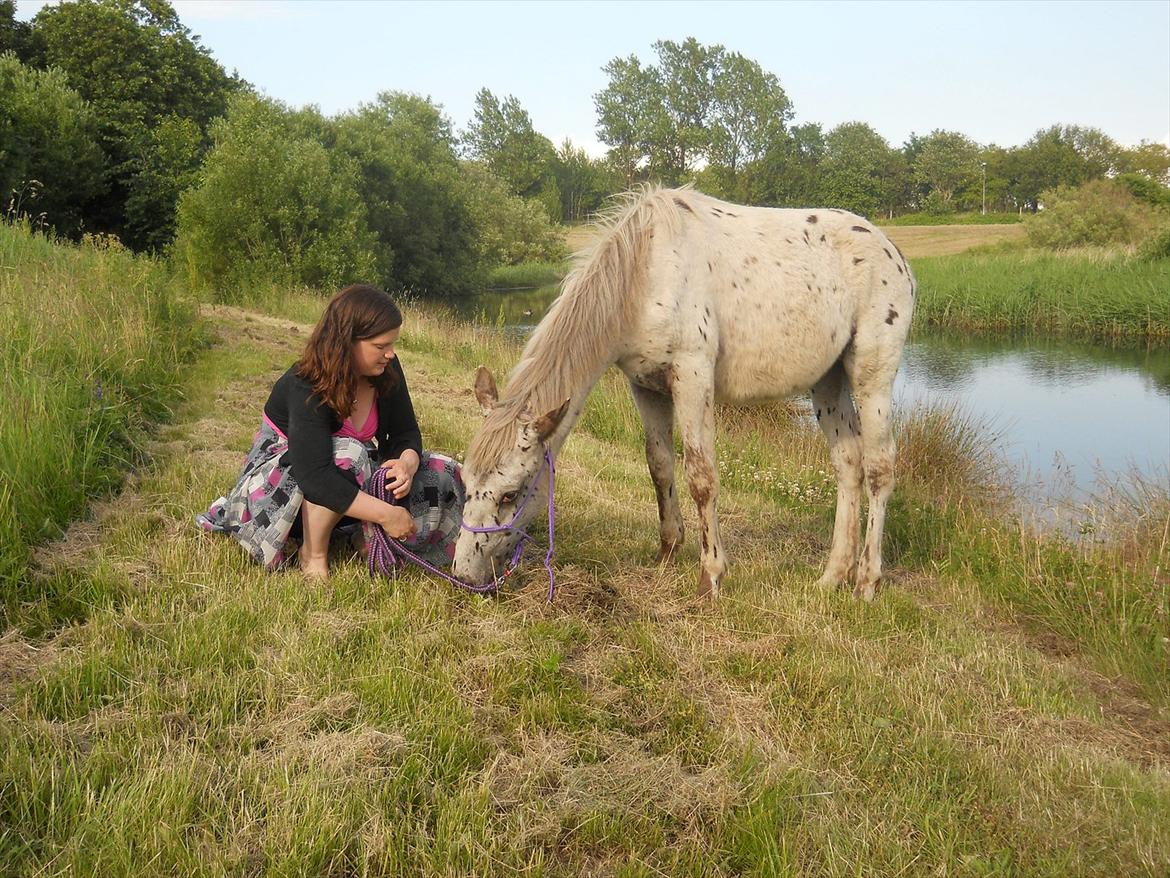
[452, 366, 569, 584]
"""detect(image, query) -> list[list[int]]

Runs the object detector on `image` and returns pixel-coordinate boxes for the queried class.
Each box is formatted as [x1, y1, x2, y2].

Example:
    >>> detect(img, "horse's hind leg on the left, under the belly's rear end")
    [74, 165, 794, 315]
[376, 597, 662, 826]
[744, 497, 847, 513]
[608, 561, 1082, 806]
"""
[812, 362, 861, 594]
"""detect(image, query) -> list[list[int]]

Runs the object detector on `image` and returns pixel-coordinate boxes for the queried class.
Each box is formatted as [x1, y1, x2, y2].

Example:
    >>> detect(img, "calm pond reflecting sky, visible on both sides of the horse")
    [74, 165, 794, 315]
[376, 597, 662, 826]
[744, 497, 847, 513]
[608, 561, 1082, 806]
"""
[453, 284, 1170, 506]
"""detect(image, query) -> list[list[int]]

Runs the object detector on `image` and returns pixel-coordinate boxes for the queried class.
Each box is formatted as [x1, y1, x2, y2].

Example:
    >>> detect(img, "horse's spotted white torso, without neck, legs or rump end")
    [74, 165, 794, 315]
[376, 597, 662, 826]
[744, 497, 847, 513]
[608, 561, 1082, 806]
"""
[640, 191, 907, 402]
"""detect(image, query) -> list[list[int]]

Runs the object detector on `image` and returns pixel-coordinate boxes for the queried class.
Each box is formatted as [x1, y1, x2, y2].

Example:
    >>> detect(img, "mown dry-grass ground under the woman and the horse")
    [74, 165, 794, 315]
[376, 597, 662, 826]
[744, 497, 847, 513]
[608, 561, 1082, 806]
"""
[0, 297, 1170, 877]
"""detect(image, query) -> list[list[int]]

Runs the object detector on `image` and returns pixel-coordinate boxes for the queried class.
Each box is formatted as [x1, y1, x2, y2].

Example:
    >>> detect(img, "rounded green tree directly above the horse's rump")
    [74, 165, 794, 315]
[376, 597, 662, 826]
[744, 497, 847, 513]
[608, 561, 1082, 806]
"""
[820, 122, 899, 217]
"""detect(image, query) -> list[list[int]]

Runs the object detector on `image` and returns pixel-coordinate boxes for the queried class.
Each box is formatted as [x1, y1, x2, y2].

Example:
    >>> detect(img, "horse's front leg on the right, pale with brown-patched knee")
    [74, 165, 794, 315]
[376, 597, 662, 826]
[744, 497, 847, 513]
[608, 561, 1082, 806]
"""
[673, 364, 727, 597]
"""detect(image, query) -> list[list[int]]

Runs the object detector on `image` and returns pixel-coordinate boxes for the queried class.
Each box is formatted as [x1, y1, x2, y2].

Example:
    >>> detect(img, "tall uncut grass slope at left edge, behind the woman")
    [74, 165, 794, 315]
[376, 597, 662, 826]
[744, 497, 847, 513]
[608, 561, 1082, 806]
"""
[0, 224, 201, 620]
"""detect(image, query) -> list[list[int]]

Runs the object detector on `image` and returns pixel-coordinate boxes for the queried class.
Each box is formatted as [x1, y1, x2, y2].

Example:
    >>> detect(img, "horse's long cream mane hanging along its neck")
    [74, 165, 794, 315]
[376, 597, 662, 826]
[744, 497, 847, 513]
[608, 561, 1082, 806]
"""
[467, 186, 691, 469]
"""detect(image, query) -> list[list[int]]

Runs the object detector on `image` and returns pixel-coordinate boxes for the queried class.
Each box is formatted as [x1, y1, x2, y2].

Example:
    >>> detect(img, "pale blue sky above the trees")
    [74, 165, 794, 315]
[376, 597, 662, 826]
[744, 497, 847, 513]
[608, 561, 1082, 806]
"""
[16, 0, 1170, 156]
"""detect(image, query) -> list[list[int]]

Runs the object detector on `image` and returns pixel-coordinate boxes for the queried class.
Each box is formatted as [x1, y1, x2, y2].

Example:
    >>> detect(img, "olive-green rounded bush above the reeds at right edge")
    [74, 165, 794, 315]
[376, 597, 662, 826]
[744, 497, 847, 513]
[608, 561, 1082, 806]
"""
[1025, 179, 1165, 249]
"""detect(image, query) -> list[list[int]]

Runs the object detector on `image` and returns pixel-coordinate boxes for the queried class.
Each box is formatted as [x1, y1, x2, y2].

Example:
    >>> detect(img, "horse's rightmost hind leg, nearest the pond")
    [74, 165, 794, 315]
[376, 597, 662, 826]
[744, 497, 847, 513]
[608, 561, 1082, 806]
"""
[846, 339, 901, 601]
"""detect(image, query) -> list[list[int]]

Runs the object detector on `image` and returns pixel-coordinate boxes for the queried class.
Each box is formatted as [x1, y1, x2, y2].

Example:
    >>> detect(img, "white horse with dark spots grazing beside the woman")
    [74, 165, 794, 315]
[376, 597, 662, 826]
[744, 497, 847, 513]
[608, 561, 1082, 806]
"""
[453, 187, 915, 601]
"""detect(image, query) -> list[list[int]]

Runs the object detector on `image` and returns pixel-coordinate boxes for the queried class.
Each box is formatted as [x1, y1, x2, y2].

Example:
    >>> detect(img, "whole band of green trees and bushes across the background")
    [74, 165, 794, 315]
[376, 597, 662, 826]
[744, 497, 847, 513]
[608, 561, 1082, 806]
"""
[0, 0, 1170, 295]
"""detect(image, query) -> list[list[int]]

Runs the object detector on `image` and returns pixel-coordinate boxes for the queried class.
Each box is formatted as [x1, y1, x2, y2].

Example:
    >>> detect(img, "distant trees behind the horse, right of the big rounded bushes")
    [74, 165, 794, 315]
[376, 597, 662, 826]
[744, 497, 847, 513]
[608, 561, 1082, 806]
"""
[464, 37, 1170, 227]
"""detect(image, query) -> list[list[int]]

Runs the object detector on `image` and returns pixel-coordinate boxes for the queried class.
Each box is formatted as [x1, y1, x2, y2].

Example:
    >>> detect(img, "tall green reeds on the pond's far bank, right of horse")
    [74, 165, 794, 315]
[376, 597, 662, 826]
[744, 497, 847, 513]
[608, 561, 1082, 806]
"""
[914, 249, 1170, 339]
